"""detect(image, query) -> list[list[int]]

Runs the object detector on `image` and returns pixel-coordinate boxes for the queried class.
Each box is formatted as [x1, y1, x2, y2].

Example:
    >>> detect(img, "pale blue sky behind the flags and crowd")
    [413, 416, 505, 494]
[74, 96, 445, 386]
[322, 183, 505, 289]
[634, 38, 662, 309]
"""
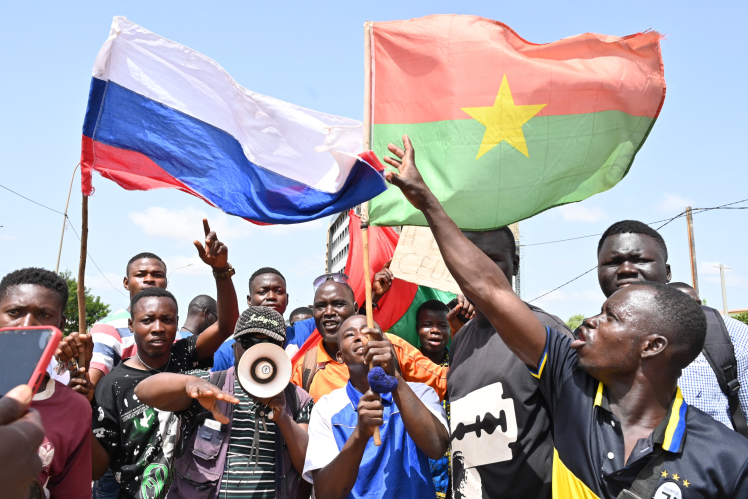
[0, 0, 748, 319]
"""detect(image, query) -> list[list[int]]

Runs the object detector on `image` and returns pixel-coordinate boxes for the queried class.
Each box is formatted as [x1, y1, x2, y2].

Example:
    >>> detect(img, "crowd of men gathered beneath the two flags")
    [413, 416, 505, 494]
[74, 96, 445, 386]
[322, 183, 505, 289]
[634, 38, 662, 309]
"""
[0, 137, 748, 499]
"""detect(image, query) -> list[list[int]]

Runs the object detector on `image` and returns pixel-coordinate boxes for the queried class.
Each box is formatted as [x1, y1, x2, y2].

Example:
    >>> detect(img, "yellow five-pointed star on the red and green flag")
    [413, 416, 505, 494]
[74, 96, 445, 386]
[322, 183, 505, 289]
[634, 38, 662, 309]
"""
[461, 75, 546, 159]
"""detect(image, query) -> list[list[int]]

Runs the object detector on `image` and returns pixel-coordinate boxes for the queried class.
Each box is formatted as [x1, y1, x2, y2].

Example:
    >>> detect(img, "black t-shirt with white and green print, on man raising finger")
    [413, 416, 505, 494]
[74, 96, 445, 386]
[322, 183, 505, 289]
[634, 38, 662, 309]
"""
[92, 336, 213, 499]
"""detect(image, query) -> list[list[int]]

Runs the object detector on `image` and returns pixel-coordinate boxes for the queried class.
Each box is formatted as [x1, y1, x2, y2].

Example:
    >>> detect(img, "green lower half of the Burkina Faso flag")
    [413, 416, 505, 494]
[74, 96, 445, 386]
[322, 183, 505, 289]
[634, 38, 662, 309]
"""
[369, 111, 655, 230]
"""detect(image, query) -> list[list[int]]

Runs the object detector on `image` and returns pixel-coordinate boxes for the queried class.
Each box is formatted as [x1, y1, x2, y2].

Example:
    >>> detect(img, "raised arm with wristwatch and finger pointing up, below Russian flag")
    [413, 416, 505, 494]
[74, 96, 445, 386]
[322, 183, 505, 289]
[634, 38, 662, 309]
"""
[194, 218, 239, 360]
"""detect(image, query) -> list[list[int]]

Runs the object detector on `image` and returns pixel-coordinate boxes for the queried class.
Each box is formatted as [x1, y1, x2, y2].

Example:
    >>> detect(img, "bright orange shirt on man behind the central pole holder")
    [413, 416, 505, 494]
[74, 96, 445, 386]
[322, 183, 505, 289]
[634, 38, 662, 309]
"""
[291, 333, 449, 402]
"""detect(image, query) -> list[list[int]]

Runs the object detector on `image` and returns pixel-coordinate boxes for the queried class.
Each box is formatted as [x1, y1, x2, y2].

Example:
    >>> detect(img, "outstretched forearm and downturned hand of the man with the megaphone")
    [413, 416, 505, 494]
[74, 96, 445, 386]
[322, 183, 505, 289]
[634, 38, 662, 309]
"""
[135, 373, 239, 424]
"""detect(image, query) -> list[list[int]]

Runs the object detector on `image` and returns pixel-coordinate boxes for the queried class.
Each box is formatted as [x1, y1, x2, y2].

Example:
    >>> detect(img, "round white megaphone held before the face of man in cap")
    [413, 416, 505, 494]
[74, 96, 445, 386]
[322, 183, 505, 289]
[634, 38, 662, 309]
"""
[236, 343, 293, 399]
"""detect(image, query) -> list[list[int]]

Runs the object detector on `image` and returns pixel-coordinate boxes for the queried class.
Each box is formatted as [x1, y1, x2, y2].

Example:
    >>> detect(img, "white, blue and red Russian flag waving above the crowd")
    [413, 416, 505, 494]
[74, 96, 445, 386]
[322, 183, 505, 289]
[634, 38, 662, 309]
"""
[81, 17, 386, 224]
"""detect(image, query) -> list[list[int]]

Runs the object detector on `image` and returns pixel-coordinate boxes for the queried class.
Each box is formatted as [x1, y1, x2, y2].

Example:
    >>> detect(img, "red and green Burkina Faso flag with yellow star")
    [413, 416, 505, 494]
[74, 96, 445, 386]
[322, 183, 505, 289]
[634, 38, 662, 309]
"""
[369, 15, 665, 230]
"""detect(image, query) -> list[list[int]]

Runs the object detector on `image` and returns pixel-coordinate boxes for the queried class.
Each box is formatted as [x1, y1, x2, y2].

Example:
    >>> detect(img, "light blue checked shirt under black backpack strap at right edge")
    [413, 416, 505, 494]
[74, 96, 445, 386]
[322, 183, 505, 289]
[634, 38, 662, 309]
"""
[678, 317, 748, 429]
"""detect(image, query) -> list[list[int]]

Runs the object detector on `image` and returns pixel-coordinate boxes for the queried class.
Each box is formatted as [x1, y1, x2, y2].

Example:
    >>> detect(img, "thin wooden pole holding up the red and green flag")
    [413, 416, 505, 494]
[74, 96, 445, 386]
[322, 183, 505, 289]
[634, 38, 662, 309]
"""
[361, 21, 382, 446]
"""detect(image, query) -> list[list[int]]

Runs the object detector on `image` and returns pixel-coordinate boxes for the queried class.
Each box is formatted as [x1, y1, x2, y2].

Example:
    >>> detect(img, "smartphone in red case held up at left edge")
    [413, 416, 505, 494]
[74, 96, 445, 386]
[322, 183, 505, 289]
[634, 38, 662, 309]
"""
[0, 326, 62, 396]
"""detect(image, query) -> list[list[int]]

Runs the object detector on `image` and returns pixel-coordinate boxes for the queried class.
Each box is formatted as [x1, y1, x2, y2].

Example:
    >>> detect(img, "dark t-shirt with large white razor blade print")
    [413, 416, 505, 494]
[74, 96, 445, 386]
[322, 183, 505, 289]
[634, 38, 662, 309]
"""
[447, 304, 571, 499]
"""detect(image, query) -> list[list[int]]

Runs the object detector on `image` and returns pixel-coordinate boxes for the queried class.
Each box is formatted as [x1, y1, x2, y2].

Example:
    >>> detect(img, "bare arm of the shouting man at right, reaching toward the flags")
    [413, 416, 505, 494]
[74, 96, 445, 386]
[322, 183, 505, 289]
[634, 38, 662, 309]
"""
[384, 135, 546, 367]
